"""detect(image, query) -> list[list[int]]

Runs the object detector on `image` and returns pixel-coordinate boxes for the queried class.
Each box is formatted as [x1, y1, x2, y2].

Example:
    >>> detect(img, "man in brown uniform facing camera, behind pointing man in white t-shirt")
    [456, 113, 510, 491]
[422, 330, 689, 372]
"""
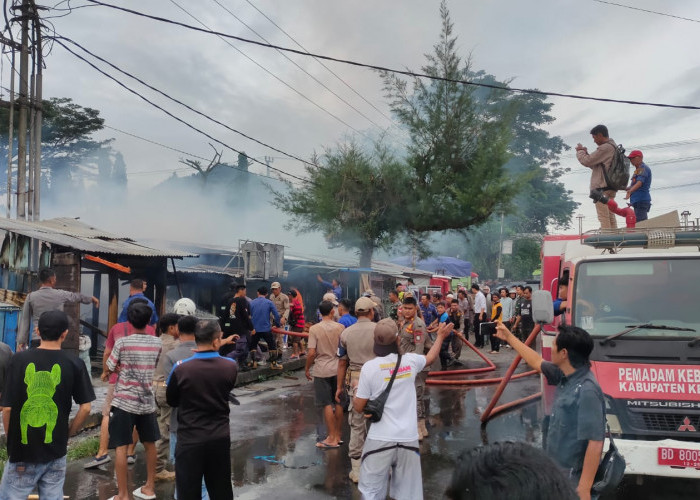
[399, 294, 432, 439]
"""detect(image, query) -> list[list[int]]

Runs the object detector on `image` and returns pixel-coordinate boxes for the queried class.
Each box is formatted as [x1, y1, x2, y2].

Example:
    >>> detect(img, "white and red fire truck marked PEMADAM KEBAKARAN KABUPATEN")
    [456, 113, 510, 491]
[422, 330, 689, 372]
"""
[541, 228, 700, 478]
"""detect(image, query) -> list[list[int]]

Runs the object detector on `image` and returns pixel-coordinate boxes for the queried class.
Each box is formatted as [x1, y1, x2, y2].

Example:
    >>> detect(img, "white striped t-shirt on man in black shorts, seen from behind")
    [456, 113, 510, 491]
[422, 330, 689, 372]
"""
[107, 333, 161, 415]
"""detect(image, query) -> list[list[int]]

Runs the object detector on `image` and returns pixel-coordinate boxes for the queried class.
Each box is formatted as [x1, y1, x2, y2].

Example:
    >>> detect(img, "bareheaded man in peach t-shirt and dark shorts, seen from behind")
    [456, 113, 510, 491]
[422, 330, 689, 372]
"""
[306, 301, 345, 449]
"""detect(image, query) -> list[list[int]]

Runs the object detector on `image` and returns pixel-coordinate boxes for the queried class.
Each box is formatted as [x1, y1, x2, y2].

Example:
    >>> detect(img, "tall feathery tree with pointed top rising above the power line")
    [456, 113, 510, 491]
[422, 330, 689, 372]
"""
[382, 2, 518, 233]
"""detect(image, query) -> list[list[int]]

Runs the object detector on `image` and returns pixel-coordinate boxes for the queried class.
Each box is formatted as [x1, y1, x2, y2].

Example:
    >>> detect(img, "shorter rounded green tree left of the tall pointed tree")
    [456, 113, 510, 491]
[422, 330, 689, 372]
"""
[274, 142, 411, 267]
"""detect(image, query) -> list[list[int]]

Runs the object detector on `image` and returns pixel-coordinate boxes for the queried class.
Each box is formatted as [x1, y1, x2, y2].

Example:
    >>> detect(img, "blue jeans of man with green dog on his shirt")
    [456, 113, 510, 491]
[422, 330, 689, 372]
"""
[0, 455, 66, 500]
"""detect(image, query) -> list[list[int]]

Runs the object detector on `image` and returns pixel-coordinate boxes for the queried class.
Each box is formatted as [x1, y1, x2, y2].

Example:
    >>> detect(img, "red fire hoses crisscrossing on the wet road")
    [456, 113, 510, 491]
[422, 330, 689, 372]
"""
[426, 329, 542, 422]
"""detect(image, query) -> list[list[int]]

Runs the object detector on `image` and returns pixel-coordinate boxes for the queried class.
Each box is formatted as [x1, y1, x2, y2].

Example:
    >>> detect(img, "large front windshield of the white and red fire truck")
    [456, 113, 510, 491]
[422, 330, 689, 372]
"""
[572, 258, 700, 338]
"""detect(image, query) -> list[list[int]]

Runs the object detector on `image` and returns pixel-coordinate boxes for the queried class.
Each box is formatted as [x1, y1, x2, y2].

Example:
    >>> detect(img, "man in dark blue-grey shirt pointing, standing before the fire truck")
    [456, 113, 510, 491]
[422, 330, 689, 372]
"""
[496, 322, 605, 500]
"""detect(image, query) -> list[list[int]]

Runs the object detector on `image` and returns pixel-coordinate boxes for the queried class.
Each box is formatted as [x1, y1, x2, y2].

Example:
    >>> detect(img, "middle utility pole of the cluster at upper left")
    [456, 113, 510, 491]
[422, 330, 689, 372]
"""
[17, 0, 29, 219]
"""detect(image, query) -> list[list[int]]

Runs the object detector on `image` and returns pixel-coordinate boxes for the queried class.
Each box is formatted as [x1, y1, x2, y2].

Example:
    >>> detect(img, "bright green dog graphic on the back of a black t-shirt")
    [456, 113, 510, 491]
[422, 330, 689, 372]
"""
[19, 363, 61, 444]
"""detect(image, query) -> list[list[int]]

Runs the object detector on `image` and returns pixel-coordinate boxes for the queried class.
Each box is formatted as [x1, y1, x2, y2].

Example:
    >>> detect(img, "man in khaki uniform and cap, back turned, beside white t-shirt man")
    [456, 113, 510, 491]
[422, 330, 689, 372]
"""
[335, 297, 377, 483]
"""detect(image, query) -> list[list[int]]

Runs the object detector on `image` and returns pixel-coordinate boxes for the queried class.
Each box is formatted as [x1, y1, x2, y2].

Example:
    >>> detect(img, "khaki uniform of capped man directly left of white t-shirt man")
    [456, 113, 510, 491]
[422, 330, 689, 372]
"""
[340, 317, 376, 460]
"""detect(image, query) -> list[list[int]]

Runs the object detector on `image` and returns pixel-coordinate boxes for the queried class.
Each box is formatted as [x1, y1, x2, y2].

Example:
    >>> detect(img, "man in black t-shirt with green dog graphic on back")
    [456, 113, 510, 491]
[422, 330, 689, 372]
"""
[0, 311, 95, 499]
